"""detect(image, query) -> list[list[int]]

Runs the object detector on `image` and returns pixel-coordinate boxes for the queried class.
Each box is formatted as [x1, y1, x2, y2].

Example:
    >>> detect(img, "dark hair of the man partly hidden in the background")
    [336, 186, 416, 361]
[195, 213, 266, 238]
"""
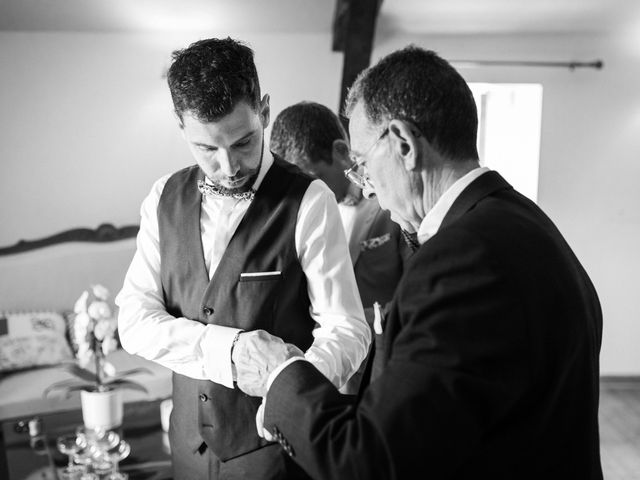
[270, 102, 348, 165]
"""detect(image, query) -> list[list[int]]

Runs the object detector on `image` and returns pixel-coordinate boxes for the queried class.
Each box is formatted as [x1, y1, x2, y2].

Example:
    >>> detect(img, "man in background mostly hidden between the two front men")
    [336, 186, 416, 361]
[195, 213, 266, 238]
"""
[269, 102, 409, 394]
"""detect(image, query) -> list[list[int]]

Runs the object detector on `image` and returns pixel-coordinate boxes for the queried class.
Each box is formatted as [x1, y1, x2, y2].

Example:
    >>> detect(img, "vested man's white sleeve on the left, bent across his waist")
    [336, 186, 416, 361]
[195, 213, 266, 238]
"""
[116, 175, 239, 388]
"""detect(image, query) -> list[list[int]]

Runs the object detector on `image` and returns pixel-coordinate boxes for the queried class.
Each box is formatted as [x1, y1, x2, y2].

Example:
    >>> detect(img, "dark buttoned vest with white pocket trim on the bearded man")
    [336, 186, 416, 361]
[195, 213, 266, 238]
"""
[158, 158, 315, 461]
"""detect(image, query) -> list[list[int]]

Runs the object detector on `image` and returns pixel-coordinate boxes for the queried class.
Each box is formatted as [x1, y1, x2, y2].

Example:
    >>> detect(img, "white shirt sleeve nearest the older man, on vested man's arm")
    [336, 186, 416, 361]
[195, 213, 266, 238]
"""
[295, 180, 371, 387]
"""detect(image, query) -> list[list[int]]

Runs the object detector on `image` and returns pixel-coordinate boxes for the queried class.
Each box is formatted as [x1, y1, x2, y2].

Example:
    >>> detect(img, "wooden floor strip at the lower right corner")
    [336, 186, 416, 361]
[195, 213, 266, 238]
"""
[599, 377, 640, 480]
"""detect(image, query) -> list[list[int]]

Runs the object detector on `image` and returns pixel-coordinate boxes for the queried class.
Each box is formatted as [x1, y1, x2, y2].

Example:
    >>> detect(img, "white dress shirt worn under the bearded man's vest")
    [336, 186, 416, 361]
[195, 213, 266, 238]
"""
[116, 147, 371, 388]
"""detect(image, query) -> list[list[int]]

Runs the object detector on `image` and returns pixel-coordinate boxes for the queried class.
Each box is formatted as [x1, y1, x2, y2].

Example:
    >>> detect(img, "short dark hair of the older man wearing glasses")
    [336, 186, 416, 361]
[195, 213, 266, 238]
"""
[345, 45, 478, 160]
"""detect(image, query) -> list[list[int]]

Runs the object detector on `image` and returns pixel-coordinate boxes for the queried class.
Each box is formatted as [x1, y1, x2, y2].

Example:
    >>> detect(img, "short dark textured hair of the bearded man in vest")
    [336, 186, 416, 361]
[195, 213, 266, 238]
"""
[167, 38, 260, 122]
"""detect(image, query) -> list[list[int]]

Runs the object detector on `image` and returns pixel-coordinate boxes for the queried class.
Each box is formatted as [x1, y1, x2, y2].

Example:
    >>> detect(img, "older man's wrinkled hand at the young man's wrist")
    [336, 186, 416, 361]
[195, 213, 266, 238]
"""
[231, 330, 303, 397]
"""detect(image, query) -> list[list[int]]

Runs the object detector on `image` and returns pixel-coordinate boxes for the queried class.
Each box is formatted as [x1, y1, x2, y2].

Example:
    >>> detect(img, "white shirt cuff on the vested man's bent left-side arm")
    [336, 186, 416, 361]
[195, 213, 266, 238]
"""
[200, 325, 242, 388]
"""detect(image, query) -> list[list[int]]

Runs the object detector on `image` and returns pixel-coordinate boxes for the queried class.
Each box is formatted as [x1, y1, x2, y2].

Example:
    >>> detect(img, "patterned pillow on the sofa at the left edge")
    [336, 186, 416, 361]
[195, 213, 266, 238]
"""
[0, 312, 73, 373]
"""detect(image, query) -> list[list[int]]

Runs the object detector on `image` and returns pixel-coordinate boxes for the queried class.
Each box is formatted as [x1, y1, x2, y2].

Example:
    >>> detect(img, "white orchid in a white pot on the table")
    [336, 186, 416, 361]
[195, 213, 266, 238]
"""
[44, 285, 151, 428]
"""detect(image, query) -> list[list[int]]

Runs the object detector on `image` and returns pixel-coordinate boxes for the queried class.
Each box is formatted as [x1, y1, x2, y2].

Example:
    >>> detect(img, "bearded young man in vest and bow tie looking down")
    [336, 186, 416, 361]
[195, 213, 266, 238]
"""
[117, 38, 370, 480]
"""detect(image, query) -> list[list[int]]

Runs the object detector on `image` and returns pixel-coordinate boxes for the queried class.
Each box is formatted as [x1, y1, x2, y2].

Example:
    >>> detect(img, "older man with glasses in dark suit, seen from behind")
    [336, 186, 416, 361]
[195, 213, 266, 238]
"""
[233, 46, 602, 480]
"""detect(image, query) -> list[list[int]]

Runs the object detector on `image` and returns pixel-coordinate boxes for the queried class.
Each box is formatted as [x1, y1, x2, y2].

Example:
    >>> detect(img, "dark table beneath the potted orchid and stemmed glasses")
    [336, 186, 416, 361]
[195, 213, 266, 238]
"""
[0, 400, 172, 480]
